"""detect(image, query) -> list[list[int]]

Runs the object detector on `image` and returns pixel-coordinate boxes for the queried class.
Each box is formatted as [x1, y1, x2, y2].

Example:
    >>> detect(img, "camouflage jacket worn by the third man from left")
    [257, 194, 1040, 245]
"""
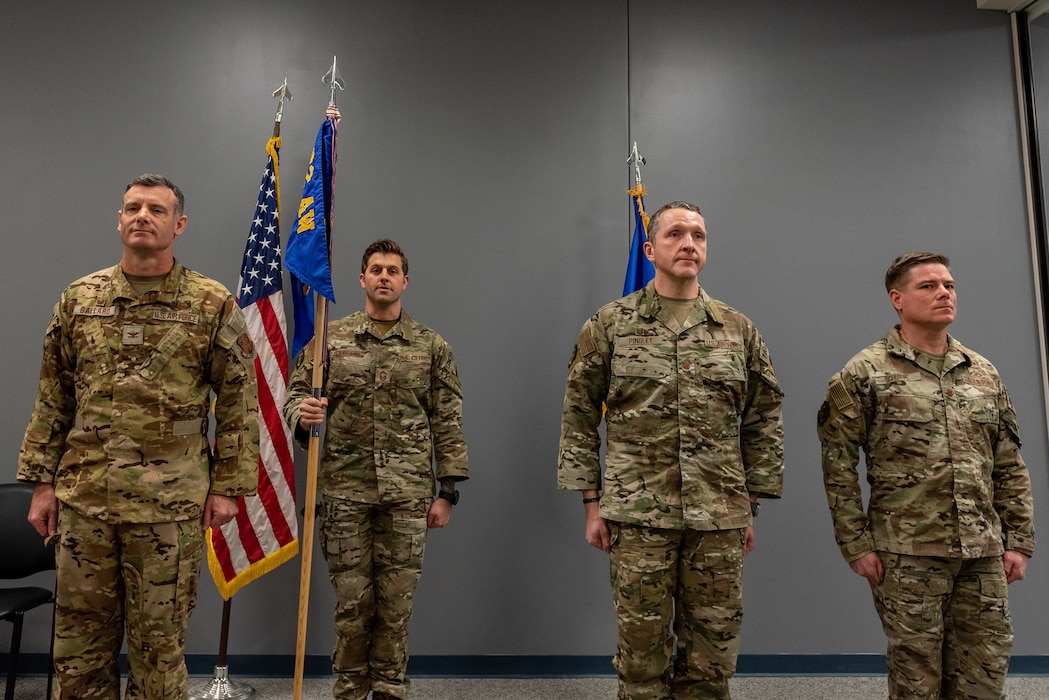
[557, 282, 784, 530]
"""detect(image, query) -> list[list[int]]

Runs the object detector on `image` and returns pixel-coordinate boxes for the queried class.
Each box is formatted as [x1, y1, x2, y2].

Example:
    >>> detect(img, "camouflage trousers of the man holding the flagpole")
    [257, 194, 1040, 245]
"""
[320, 499, 431, 700]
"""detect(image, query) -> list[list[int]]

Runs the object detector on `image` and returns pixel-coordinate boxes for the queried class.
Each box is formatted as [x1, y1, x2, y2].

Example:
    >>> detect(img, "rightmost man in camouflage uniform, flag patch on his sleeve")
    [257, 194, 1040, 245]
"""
[818, 253, 1034, 700]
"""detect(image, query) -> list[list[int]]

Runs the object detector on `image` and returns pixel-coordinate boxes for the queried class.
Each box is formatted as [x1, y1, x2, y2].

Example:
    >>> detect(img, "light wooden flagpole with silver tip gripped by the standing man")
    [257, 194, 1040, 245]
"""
[293, 57, 345, 700]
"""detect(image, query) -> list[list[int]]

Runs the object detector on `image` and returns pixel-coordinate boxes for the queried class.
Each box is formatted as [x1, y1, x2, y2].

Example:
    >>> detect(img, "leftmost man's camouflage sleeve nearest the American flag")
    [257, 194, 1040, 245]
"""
[209, 296, 259, 496]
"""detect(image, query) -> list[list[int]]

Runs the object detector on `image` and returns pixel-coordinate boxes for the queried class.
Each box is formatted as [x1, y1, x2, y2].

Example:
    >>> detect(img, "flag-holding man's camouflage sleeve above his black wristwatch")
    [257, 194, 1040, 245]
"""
[430, 340, 469, 481]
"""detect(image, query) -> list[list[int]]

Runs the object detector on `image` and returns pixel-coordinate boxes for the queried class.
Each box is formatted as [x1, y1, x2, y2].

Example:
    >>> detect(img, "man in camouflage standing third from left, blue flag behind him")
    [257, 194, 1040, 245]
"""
[557, 201, 784, 700]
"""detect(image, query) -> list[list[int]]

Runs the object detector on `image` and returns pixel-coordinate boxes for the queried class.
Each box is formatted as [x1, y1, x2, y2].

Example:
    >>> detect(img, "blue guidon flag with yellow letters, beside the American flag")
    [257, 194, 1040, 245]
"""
[284, 114, 338, 356]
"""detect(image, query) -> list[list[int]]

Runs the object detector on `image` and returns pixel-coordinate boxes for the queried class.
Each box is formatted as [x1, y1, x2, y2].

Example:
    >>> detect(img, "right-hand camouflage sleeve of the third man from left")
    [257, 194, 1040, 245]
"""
[740, 331, 784, 499]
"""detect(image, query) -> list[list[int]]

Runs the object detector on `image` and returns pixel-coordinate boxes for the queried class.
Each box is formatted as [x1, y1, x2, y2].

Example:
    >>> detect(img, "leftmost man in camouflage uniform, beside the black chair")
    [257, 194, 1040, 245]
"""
[18, 175, 258, 700]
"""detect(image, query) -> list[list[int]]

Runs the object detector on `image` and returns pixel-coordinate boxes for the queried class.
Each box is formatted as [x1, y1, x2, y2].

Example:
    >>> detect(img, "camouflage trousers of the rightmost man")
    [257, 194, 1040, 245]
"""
[872, 552, 1012, 700]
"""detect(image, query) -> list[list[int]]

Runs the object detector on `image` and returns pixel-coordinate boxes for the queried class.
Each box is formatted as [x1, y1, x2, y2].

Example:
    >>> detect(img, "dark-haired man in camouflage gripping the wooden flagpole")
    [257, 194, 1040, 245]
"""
[284, 238, 468, 700]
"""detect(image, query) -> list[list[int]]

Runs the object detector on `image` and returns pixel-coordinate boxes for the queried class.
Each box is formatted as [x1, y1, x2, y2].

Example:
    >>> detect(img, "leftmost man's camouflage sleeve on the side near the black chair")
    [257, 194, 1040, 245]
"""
[18, 301, 77, 484]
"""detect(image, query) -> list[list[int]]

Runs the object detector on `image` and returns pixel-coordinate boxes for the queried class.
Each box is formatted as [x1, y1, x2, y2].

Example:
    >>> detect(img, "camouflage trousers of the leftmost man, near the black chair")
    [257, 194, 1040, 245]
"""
[52, 504, 205, 700]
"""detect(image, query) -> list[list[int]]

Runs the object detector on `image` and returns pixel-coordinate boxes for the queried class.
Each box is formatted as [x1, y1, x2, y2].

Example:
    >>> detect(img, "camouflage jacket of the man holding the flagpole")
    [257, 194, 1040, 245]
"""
[284, 311, 468, 504]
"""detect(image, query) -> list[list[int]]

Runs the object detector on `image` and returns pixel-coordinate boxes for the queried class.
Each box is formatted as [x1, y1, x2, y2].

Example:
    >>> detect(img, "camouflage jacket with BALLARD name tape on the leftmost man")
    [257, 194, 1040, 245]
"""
[18, 261, 258, 523]
